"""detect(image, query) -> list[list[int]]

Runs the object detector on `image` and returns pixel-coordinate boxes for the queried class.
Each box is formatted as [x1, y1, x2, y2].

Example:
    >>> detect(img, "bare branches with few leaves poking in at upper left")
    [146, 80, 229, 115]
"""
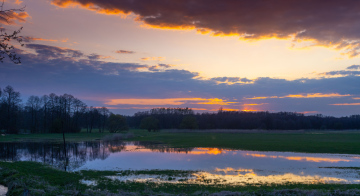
[0, 0, 25, 64]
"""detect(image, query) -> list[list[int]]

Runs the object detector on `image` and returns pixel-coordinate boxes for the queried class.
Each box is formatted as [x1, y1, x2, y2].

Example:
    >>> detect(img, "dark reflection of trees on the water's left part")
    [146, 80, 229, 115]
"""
[0, 140, 193, 171]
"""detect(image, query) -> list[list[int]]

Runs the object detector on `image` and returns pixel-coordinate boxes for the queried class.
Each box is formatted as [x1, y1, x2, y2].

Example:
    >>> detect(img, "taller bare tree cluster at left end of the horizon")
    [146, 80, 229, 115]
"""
[0, 86, 128, 134]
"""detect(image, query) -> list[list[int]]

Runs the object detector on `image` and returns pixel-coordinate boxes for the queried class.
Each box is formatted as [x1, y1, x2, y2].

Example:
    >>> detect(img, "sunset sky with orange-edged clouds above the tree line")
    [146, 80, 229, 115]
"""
[0, 0, 360, 116]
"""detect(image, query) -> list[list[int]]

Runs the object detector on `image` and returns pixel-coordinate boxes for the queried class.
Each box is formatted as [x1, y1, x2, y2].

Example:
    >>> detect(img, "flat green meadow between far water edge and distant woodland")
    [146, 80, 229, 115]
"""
[129, 130, 360, 154]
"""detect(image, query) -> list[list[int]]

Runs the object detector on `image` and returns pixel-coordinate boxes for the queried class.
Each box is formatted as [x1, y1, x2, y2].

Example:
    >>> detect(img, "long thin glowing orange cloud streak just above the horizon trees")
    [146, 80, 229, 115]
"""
[105, 98, 235, 105]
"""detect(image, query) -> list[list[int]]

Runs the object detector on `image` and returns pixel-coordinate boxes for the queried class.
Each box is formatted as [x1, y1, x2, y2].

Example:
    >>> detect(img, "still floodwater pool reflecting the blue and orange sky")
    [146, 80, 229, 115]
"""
[0, 141, 360, 184]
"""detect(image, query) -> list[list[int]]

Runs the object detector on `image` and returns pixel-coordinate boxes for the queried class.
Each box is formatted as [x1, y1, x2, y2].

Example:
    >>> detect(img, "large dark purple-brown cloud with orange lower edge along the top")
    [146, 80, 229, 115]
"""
[53, 0, 360, 57]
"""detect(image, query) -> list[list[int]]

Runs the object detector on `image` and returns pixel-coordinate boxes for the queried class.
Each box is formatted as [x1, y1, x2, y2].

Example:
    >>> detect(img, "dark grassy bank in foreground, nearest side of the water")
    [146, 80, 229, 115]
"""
[0, 162, 360, 195]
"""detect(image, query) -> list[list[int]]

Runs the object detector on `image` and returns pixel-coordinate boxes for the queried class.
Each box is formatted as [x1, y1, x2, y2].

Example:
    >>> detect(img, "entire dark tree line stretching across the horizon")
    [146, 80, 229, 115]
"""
[0, 86, 360, 134]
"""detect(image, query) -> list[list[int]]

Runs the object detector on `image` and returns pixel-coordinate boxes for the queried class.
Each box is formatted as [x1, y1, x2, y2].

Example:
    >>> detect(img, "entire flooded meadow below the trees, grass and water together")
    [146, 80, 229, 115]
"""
[0, 130, 360, 195]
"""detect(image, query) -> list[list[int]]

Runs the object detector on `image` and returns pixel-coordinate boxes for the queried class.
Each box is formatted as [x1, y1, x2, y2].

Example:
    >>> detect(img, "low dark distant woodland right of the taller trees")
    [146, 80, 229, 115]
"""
[128, 108, 360, 130]
